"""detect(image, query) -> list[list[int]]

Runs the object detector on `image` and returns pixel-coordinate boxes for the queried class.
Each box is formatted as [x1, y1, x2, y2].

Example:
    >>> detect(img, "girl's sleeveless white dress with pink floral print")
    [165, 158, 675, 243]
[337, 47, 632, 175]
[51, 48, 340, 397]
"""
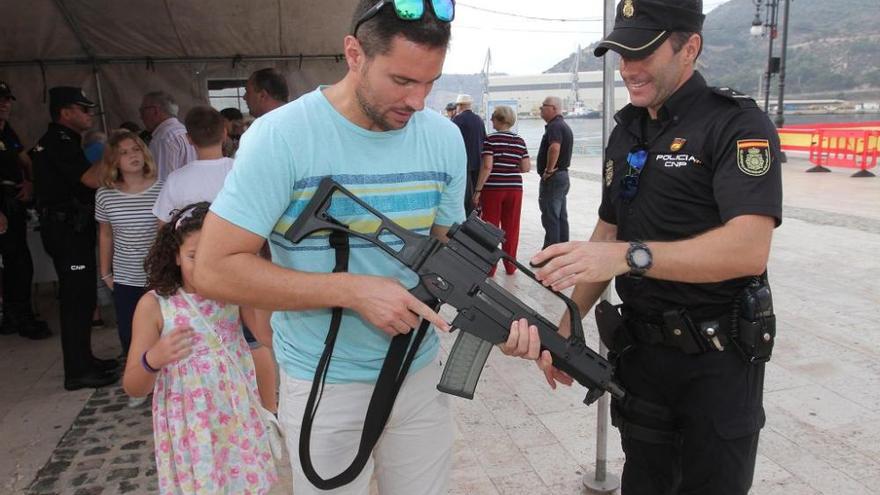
[151, 292, 277, 495]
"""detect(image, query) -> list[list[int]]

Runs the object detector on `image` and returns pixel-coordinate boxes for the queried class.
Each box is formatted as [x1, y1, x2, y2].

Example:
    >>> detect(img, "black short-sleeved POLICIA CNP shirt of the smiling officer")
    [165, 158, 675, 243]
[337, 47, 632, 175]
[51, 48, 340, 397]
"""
[599, 72, 782, 322]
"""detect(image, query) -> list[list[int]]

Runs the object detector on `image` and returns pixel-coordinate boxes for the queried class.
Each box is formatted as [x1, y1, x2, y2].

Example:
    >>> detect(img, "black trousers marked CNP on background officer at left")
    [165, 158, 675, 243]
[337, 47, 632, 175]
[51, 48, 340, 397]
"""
[40, 216, 97, 379]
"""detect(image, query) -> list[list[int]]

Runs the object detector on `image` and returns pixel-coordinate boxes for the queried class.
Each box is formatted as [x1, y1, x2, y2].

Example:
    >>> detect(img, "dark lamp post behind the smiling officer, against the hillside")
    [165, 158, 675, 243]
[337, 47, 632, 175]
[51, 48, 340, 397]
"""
[749, 0, 791, 127]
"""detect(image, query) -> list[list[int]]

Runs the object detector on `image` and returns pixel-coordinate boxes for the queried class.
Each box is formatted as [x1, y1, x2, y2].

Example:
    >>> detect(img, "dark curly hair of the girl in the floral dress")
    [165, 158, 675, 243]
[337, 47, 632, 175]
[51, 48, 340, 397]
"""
[144, 201, 211, 297]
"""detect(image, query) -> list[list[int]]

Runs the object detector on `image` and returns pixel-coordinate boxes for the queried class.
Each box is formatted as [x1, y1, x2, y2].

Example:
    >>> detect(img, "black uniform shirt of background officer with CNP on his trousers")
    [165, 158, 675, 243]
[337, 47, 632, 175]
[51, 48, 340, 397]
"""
[30, 122, 95, 210]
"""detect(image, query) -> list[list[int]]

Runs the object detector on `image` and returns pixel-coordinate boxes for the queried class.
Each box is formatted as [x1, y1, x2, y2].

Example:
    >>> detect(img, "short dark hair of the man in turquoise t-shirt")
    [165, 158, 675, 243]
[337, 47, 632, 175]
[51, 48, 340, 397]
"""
[349, 0, 452, 58]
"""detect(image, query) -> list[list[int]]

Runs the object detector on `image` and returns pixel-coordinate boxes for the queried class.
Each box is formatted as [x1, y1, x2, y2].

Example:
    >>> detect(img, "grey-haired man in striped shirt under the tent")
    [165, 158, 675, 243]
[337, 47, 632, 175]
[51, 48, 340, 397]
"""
[138, 91, 197, 180]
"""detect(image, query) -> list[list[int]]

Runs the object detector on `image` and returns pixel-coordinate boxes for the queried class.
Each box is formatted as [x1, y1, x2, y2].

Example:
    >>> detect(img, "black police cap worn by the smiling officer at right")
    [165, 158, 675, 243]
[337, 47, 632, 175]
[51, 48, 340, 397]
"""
[593, 0, 706, 59]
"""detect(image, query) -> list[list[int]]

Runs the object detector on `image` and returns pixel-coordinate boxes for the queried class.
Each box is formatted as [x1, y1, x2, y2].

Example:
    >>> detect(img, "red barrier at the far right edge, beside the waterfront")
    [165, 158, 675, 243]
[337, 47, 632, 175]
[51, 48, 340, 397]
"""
[807, 128, 880, 177]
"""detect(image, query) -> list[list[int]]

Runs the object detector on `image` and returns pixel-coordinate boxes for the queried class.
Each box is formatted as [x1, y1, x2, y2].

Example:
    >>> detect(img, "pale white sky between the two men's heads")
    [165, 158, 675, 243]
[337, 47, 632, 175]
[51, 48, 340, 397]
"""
[443, 0, 727, 75]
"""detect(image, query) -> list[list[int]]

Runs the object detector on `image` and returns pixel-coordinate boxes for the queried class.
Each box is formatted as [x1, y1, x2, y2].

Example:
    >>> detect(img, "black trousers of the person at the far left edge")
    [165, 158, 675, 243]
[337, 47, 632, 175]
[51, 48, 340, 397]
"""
[0, 199, 34, 315]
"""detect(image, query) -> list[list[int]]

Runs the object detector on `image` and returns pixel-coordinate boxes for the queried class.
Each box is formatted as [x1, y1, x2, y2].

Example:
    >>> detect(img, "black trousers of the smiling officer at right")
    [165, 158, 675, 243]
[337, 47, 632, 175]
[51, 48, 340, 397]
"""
[612, 344, 764, 495]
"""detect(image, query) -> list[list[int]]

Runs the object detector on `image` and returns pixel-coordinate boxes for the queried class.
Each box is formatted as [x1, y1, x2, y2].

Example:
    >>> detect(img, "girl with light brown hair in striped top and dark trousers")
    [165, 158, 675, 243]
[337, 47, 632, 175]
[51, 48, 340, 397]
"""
[95, 130, 162, 366]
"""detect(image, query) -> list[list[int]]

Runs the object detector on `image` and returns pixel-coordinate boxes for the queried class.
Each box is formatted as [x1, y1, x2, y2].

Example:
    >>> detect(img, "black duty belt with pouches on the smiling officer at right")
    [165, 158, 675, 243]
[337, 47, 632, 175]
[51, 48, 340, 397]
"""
[623, 309, 731, 354]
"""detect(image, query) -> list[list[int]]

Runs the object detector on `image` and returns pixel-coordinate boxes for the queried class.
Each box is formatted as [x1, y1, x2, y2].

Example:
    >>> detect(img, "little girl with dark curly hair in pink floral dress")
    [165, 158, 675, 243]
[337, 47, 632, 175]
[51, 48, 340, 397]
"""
[123, 202, 277, 495]
